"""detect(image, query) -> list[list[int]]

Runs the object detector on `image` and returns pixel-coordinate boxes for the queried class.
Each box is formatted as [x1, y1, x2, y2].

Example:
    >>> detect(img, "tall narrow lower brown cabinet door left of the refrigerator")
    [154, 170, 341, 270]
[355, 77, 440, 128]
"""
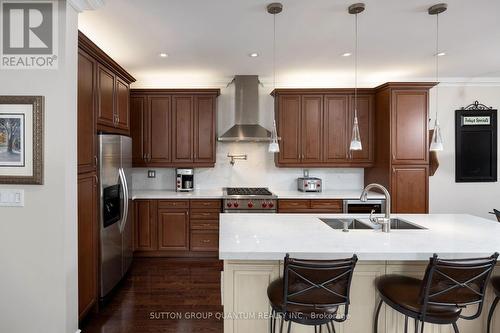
[78, 173, 97, 319]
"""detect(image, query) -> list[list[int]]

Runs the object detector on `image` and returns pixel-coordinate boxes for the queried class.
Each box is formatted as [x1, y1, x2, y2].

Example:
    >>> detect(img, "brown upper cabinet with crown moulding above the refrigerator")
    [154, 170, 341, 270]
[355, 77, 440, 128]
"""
[78, 32, 135, 135]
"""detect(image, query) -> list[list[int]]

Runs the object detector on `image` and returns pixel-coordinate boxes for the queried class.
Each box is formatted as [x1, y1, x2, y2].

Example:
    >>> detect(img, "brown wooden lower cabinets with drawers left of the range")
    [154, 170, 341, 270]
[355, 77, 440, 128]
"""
[134, 199, 222, 258]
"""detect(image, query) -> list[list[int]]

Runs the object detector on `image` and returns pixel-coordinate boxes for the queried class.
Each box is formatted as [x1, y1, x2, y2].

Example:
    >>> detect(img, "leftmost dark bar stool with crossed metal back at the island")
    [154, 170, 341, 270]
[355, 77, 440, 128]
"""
[267, 254, 358, 333]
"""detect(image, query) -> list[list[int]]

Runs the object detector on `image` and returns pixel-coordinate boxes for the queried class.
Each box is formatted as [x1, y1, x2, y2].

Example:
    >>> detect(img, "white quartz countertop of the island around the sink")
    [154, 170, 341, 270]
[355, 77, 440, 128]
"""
[219, 214, 500, 261]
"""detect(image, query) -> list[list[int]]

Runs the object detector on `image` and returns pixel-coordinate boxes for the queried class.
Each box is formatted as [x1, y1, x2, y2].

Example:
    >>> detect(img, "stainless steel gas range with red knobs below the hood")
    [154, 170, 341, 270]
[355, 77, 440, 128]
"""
[223, 187, 278, 213]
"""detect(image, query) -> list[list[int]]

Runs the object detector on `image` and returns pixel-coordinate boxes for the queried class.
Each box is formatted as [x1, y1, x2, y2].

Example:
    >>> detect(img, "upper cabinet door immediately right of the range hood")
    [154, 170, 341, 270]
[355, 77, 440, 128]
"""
[278, 95, 301, 164]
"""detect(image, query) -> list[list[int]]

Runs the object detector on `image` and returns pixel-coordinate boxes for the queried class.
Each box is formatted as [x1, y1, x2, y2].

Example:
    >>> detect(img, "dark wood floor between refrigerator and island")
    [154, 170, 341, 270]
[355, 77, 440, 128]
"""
[82, 258, 223, 333]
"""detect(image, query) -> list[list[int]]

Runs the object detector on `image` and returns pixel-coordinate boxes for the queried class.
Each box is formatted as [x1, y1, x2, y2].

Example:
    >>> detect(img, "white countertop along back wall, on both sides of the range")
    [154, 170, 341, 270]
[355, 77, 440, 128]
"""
[132, 188, 384, 200]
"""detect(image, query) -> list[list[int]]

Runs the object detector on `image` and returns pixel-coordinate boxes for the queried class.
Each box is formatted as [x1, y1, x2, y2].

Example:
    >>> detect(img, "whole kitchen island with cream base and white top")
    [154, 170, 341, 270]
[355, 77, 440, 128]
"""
[219, 214, 500, 333]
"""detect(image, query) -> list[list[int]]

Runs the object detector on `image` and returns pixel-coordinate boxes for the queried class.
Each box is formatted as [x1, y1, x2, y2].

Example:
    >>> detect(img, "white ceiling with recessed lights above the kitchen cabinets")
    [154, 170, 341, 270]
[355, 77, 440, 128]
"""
[79, 0, 500, 87]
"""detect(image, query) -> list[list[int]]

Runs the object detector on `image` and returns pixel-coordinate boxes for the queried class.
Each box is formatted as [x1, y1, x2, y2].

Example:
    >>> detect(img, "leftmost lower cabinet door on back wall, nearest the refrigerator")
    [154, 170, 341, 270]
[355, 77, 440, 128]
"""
[134, 200, 158, 251]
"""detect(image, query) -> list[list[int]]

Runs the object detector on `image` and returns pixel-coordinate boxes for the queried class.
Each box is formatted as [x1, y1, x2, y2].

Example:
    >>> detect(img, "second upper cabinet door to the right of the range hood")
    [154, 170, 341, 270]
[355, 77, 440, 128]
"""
[300, 95, 323, 164]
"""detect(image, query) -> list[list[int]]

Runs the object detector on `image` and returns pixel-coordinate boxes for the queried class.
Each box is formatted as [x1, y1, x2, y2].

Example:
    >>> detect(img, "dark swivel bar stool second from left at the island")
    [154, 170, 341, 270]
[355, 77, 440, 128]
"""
[374, 253, 498, 333]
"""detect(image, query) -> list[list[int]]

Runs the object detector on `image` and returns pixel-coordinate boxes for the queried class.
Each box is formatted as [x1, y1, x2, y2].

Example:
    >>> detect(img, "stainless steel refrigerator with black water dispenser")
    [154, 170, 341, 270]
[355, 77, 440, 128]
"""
[99, 134, 133, 298]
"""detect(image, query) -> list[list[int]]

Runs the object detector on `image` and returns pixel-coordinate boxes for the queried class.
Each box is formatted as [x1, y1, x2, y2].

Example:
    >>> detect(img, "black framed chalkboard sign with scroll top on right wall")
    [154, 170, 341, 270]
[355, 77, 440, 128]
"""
[455, 101, 497, 183]
